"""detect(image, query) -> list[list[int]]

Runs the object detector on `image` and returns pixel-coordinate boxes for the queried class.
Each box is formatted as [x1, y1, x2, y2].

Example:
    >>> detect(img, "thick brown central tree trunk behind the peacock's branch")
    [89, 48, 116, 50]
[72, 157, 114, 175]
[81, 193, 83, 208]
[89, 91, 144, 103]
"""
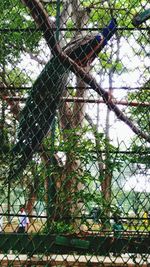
[57, 0, 87, 229]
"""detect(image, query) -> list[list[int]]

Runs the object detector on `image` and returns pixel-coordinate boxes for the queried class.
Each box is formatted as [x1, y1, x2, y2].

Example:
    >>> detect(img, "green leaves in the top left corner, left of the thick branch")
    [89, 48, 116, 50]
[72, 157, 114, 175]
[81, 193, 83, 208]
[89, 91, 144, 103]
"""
[0, 0, 41, 65]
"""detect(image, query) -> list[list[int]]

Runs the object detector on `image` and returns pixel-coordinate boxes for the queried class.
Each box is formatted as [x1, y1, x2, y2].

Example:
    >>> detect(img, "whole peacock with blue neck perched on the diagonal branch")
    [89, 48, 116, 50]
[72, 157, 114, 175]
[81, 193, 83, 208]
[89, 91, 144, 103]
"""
[9, 19, 117, 179]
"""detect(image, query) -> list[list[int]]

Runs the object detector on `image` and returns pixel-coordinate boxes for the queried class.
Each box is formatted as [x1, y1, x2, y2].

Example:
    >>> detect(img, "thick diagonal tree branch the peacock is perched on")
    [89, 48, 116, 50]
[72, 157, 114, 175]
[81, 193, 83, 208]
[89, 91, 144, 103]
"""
[22, 0, 150, 143]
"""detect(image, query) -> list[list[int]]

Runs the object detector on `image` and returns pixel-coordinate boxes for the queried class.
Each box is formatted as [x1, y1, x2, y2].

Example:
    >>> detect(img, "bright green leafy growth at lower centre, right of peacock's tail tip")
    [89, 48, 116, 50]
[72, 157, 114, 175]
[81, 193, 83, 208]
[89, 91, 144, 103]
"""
[43, 127, 125, 215]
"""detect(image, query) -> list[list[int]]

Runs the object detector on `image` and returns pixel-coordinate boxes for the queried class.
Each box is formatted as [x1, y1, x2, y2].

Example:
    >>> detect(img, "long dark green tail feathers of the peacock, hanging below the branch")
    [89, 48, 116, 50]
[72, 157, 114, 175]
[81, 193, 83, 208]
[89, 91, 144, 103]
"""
[9, 57, 68, 181]
